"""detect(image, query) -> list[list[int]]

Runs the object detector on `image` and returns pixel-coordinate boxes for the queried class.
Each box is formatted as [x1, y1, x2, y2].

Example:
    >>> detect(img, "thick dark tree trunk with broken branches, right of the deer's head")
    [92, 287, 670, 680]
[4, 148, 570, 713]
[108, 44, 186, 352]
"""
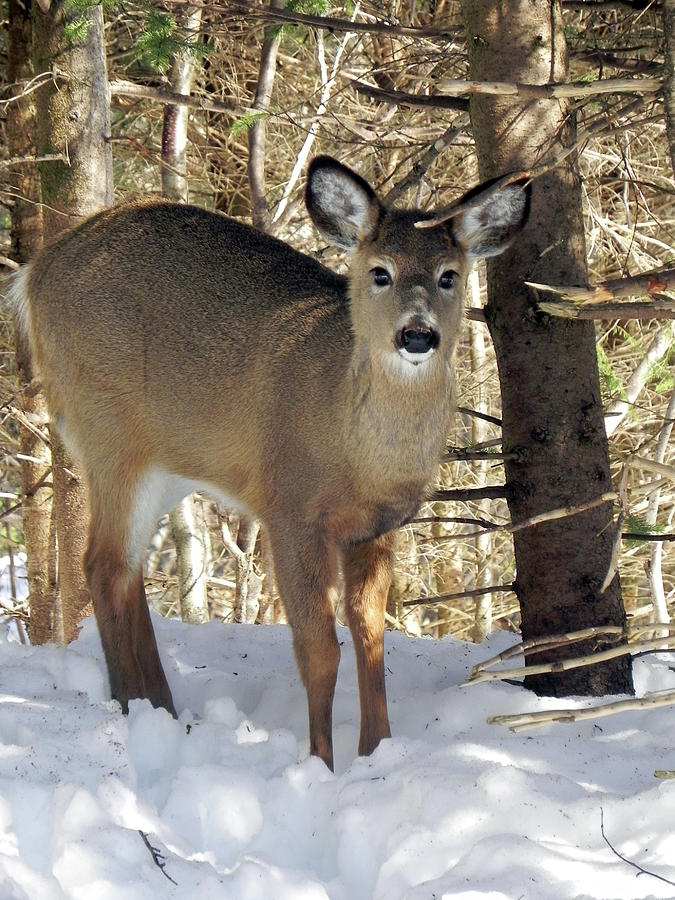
[463, 0, 632, 695]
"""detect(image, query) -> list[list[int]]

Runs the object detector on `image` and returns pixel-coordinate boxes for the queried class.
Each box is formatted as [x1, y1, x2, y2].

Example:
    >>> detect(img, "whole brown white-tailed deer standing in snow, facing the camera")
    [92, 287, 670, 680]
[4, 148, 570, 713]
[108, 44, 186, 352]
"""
[10, 157, 527, 767]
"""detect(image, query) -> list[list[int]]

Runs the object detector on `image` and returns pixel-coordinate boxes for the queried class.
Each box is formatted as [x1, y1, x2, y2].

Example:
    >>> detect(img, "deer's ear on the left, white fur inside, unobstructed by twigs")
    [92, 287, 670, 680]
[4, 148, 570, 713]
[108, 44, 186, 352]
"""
[305, 156, 382, 250]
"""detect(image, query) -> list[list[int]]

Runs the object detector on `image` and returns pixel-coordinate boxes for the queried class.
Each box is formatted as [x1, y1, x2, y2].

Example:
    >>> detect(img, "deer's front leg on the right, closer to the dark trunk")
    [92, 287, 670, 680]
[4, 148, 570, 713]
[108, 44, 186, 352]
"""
[343, 533, 394, 756]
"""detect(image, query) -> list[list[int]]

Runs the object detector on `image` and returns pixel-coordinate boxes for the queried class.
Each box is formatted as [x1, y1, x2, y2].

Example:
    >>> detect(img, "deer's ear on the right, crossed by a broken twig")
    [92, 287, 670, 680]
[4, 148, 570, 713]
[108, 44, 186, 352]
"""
[451, 181, 531, 260]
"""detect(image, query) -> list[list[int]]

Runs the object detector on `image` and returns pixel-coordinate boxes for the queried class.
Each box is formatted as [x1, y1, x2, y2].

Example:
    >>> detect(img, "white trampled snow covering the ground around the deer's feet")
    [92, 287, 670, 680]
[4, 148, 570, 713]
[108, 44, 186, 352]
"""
[0, 617, 675, 900]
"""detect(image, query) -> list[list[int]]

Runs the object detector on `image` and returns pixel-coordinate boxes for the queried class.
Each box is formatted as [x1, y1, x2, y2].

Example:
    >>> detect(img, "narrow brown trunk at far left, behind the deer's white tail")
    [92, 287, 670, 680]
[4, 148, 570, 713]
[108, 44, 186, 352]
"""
[7, 0, 54, 644]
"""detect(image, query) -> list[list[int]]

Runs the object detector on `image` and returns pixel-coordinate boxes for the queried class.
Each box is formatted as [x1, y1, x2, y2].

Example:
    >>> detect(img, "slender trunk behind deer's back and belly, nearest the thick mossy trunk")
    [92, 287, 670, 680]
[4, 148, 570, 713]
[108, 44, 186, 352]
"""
[162, 7, 209, 624]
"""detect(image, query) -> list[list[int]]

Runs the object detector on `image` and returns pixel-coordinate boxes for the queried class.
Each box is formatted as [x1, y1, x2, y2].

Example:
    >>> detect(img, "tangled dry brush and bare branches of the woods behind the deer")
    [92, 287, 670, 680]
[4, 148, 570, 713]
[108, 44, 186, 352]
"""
[0, 0, 675, 688]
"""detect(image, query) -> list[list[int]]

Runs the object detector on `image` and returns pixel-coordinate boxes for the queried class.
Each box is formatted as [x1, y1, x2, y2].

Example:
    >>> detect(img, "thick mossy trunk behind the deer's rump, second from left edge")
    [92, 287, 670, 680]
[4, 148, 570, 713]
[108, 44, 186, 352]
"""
[34, 0, 113, 642]
